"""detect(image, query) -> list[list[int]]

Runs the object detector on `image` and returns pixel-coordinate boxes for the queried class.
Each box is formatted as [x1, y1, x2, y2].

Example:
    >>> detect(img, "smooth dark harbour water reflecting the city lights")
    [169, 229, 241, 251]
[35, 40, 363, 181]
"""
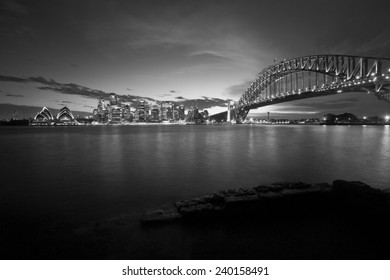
[0, 125, 390, 258]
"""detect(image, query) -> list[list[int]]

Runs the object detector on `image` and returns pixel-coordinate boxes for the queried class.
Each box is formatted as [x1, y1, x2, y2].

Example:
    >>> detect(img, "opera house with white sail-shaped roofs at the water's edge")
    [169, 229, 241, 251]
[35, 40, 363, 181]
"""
[31, 106, 79, 125]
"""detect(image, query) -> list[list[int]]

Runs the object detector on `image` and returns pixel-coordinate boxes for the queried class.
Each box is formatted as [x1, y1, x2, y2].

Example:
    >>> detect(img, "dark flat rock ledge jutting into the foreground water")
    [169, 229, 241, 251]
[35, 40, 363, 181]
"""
[141, 180, 390, 224]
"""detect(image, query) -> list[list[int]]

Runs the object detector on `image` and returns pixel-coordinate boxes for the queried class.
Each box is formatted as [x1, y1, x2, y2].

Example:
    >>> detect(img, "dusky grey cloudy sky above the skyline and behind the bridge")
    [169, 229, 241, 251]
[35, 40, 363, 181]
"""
[0, 0, 390, 118]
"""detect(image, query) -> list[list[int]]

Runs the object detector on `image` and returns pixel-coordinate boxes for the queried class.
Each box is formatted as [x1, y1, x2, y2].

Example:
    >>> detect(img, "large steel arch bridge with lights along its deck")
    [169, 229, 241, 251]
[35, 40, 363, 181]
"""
[230, 55, 390, 123]
